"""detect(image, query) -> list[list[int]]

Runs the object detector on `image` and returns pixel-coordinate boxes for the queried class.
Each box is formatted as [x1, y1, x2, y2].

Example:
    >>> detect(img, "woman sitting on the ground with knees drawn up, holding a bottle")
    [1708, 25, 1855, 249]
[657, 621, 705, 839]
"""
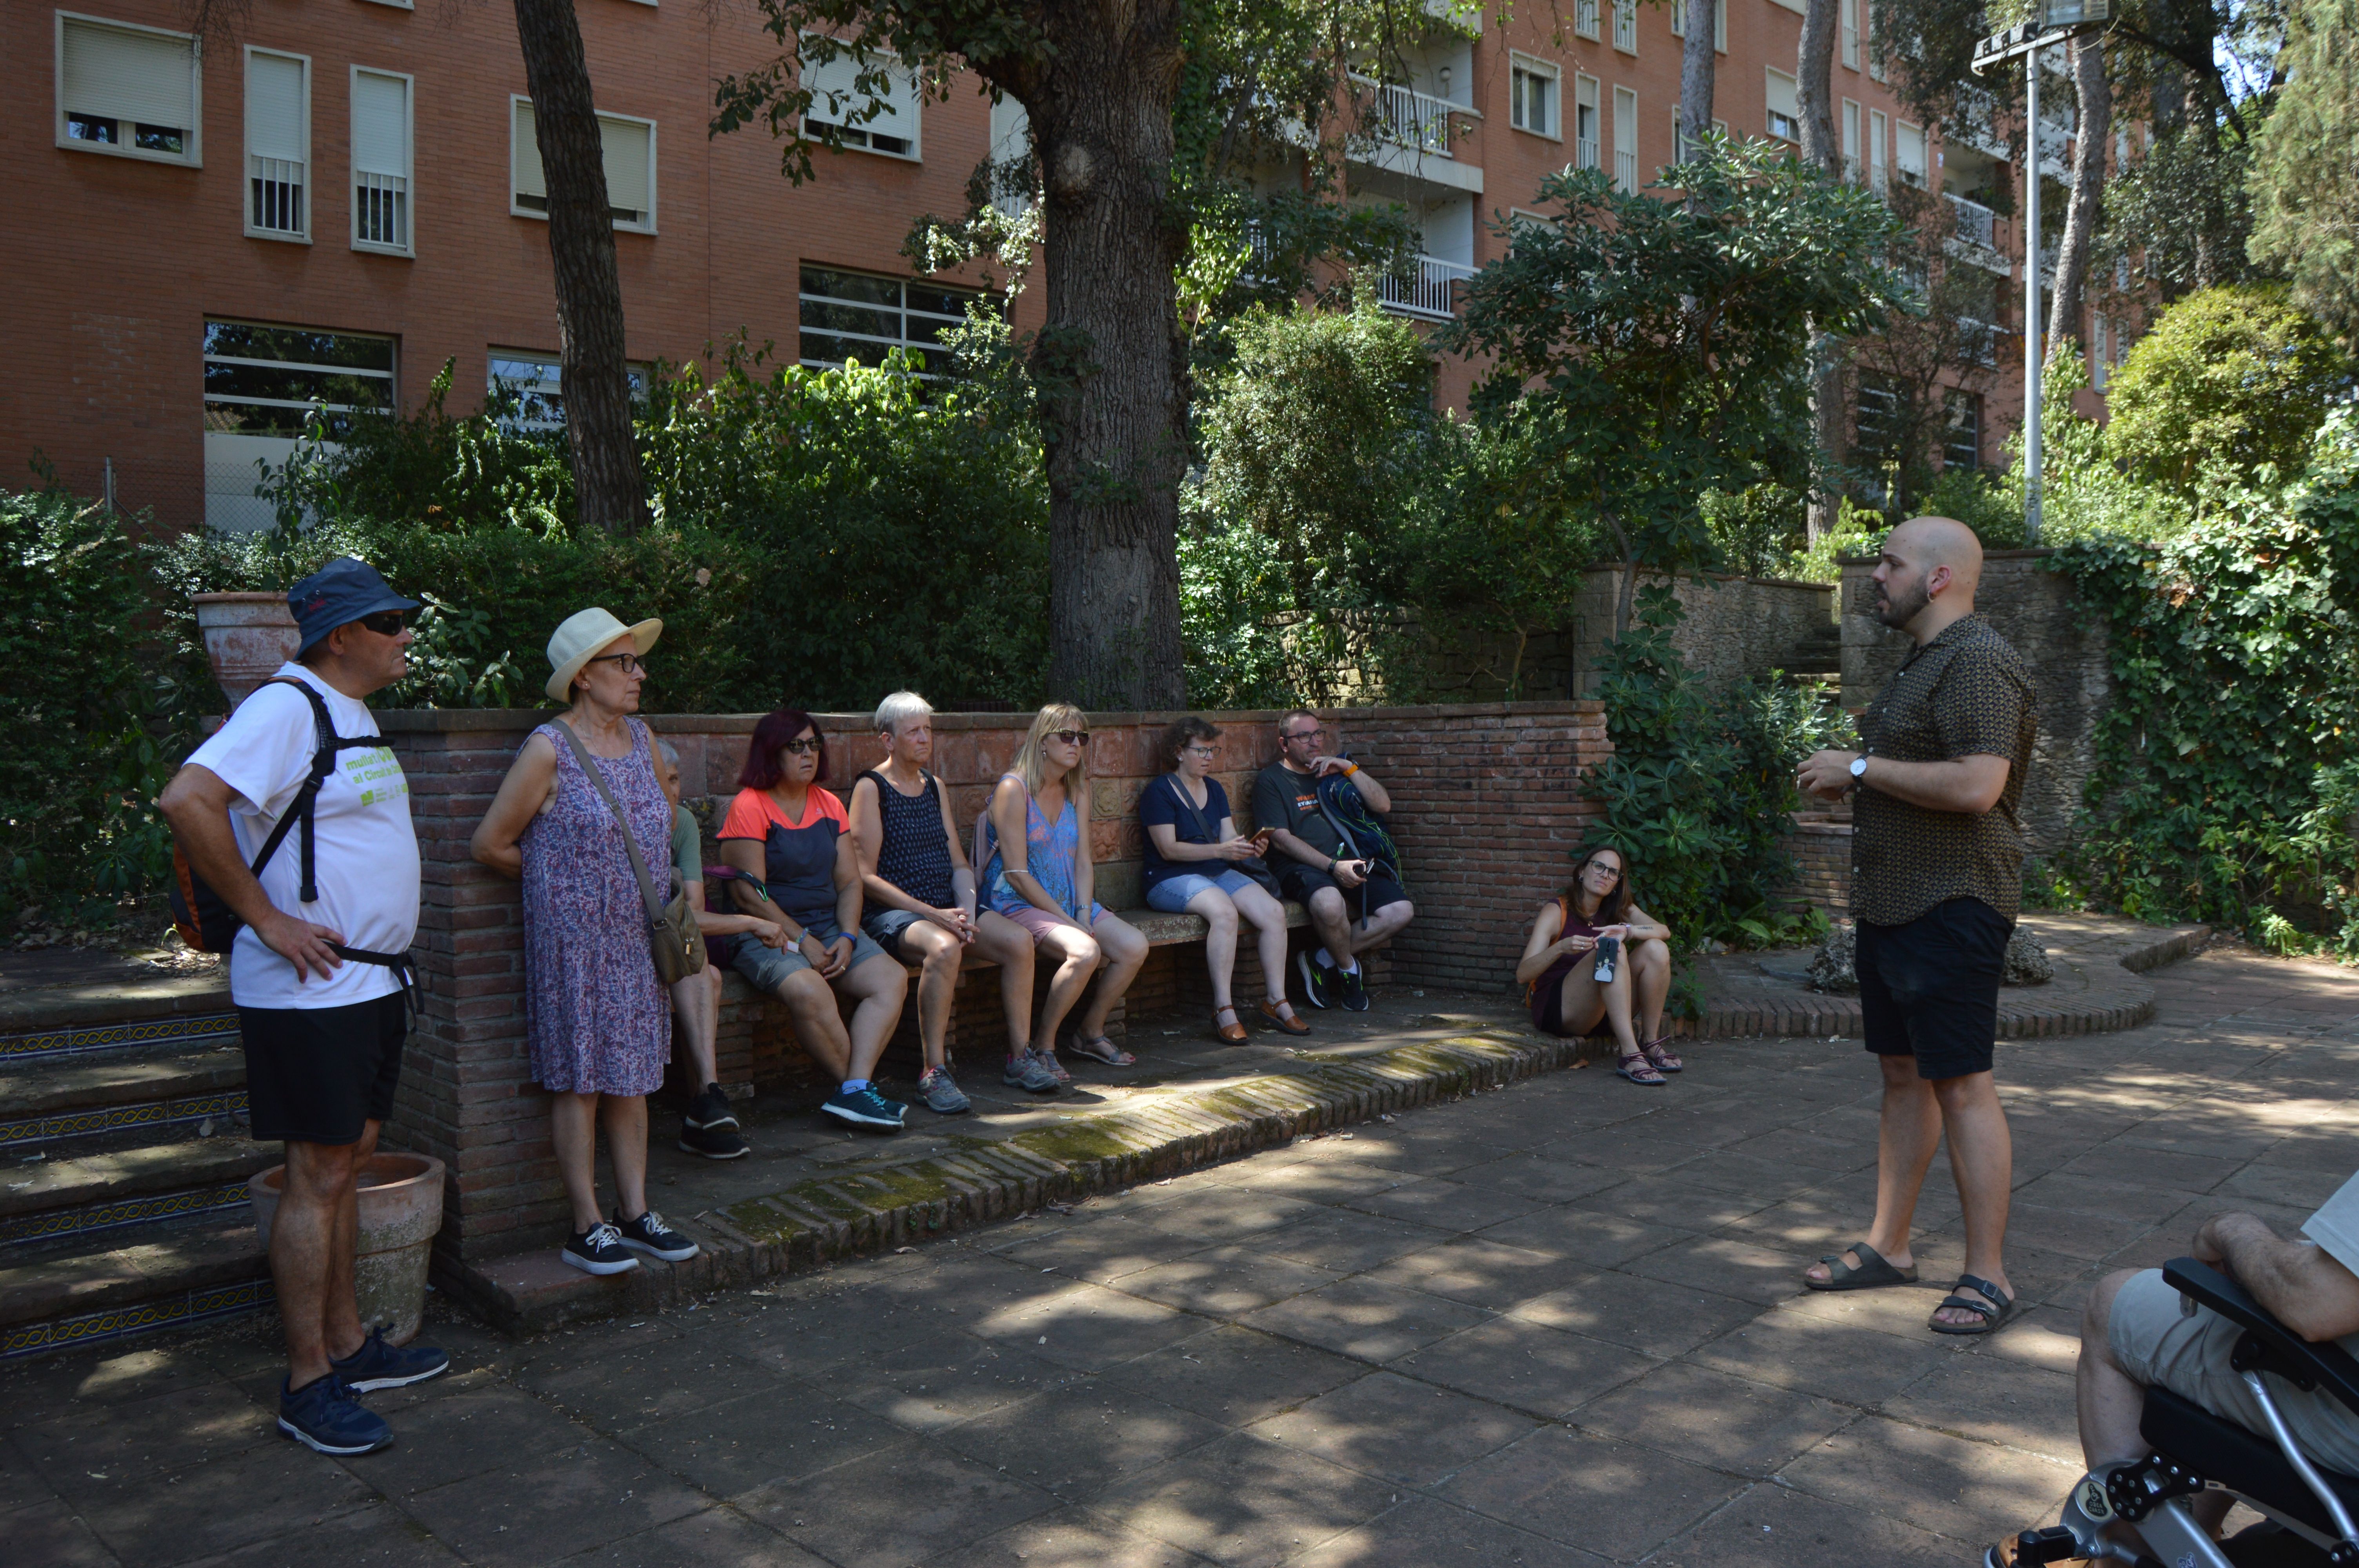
[1514, 844, 1687, 1085]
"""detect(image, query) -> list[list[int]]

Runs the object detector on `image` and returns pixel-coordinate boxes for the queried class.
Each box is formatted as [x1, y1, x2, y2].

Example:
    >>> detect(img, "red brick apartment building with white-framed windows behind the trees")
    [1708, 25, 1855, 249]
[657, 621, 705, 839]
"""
[0, 0, 2064, 528]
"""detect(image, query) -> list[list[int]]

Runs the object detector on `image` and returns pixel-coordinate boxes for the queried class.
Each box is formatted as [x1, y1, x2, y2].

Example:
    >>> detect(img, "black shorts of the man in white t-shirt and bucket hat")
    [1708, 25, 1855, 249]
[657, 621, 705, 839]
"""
[238, 990, 411, 1146]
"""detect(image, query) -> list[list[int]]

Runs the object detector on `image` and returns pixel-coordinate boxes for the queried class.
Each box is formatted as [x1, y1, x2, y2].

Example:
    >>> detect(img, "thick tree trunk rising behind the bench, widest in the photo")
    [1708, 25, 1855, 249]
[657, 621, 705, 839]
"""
[1024, 0, 1187, 710]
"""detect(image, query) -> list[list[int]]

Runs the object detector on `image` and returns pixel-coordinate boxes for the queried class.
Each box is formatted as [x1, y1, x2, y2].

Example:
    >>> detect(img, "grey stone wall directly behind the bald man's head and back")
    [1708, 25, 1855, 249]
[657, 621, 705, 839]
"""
[1842, 550, 2114, 858]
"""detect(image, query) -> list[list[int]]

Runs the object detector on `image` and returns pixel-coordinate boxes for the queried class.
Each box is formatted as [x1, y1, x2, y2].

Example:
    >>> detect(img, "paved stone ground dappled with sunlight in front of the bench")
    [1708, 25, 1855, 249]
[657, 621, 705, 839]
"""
[0, 933, 2359, 1568]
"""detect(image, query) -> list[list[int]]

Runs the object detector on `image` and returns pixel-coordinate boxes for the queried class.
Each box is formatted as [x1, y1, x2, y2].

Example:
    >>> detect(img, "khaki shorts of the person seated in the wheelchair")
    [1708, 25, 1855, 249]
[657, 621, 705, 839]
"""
[2104, 1269, 2359, 1476]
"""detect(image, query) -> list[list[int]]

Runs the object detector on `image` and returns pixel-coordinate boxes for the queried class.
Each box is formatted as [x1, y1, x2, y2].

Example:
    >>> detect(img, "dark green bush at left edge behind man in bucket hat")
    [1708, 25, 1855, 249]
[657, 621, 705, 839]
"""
[0, 490, 172, 924]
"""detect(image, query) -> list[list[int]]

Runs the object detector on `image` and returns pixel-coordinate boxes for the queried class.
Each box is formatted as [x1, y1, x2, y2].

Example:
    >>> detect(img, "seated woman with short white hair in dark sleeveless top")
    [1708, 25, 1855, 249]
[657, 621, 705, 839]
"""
[849, 691, 1057, 1115]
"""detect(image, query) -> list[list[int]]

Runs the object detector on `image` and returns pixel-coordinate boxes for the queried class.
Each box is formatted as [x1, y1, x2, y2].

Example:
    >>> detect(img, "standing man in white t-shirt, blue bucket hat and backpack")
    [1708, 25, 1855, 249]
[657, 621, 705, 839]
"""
[158, 557, 451, 1455]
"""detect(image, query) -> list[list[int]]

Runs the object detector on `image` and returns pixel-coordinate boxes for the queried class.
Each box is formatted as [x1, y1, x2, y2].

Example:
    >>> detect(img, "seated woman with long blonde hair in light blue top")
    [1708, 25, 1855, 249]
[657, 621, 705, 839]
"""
[984, 702, 1147, 1085]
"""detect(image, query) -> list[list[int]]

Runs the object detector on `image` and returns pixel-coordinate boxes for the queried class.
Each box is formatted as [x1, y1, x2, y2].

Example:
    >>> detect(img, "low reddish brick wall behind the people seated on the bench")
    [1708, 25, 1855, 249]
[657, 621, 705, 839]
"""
[380, 702, 1611, 1264]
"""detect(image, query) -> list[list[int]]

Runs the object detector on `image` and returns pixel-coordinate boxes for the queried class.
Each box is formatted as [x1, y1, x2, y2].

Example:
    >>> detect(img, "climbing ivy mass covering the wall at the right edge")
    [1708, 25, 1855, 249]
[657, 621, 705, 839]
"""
[2057, 410, 2359, 955]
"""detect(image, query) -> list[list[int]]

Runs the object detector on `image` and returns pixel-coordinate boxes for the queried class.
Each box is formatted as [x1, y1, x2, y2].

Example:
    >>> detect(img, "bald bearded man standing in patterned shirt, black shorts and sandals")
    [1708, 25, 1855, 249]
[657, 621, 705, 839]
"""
[1795, 516, 2036, 1335]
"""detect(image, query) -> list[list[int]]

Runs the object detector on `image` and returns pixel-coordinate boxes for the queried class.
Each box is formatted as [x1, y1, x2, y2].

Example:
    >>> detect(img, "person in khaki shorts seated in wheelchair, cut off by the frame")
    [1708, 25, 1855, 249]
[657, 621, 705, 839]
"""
[2028, 1177, 2359, 1561]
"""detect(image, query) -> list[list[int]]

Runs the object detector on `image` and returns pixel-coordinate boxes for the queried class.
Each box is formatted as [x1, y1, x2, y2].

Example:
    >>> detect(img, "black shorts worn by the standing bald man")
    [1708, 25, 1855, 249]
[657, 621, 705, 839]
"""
[1857, 898, 2015, 1078]
